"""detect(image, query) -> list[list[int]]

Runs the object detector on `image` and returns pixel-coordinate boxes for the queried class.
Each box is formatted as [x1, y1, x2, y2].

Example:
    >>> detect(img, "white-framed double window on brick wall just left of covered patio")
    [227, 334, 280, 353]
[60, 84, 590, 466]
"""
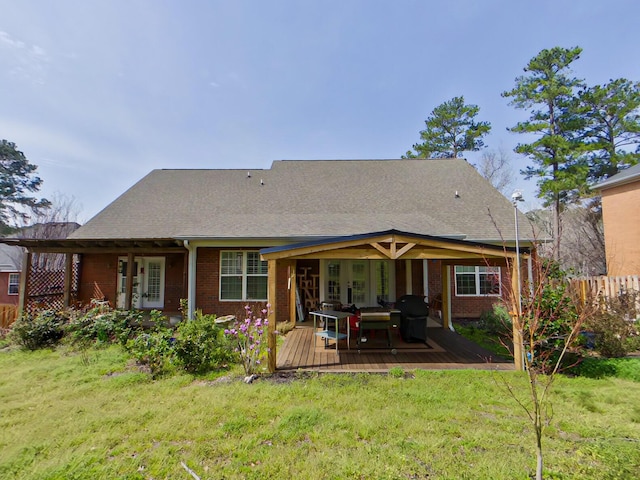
[220, 250, 268, 301]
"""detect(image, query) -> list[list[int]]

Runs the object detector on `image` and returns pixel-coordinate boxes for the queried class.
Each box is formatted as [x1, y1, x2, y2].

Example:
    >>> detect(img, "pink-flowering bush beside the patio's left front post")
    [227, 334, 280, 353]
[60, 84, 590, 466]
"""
[224, 304, 270, 375]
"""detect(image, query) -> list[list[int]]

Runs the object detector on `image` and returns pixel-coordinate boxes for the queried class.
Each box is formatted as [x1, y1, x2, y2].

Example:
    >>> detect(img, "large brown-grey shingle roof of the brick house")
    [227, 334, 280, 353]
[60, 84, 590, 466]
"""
[69, 159, 532, 241]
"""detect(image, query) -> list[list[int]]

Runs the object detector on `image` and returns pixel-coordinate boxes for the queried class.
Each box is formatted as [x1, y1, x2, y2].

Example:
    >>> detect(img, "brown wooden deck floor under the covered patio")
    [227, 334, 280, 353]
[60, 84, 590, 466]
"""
[276, 322, 514, 372]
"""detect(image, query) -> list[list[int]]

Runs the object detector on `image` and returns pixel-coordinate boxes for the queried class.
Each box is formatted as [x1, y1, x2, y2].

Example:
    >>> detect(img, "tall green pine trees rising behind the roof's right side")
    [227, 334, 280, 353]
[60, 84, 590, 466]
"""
[403, 47, 640, 259]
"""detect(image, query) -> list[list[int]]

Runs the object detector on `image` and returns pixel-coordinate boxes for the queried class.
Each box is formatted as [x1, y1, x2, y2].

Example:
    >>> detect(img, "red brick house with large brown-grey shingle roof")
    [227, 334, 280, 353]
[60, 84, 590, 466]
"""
[6, 158, 533, 370]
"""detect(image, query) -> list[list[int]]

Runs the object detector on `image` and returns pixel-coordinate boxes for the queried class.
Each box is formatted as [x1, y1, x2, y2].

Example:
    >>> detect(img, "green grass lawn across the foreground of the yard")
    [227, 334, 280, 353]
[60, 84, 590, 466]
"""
[0, 346, 640, 480]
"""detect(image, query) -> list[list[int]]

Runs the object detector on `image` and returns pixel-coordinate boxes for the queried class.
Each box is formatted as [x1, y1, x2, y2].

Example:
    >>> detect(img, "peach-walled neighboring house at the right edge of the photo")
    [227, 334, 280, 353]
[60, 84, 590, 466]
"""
[595, 164, 640, 277]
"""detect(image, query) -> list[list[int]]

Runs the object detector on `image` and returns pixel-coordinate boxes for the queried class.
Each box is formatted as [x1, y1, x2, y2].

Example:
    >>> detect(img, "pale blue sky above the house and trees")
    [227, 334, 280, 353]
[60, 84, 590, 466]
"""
[0, 0, 640, 221]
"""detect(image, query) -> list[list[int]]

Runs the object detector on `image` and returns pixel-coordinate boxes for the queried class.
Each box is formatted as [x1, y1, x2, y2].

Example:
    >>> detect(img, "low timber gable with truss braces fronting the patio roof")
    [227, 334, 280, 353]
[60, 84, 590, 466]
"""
[260, 230, 528, 260]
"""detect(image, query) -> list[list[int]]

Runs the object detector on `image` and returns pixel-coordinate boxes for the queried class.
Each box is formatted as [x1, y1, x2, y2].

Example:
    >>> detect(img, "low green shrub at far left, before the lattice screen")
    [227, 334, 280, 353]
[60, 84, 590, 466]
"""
[10, 310, 69, 350]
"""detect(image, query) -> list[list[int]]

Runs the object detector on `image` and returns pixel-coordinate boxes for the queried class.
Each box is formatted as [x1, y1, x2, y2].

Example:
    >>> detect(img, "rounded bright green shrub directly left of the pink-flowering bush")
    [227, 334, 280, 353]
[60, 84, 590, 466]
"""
[175, 311, 237, 373]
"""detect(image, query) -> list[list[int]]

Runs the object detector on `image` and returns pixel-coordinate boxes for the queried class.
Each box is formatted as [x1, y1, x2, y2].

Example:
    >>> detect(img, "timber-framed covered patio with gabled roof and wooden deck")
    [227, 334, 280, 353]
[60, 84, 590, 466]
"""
[260, 230, 528, 372]
